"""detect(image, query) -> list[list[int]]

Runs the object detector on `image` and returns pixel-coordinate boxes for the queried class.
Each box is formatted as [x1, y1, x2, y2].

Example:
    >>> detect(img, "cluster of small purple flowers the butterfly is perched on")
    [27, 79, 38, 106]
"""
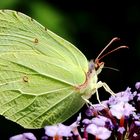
[10, 82, 140, 140]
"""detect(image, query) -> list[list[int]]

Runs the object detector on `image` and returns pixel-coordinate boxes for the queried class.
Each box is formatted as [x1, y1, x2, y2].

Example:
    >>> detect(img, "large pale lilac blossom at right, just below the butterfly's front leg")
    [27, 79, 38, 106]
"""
[110, 102, 136, 119]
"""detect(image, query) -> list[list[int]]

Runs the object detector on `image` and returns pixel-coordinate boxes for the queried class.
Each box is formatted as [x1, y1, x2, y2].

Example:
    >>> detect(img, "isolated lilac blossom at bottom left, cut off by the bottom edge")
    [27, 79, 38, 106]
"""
[9, 133, 37, 140]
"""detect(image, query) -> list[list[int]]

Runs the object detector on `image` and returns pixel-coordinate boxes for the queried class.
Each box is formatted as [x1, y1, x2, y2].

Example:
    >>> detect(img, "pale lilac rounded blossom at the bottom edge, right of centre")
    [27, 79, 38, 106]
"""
[86, 124, 111, 140]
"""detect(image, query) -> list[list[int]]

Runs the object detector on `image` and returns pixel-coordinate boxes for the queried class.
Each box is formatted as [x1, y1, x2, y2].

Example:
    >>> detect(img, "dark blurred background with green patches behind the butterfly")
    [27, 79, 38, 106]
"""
[0, 0, 140, 139]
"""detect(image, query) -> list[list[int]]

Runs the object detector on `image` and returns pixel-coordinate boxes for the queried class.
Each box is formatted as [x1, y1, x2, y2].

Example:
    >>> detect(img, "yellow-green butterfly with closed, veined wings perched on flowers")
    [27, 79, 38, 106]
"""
[0, 10, 127, 128]
